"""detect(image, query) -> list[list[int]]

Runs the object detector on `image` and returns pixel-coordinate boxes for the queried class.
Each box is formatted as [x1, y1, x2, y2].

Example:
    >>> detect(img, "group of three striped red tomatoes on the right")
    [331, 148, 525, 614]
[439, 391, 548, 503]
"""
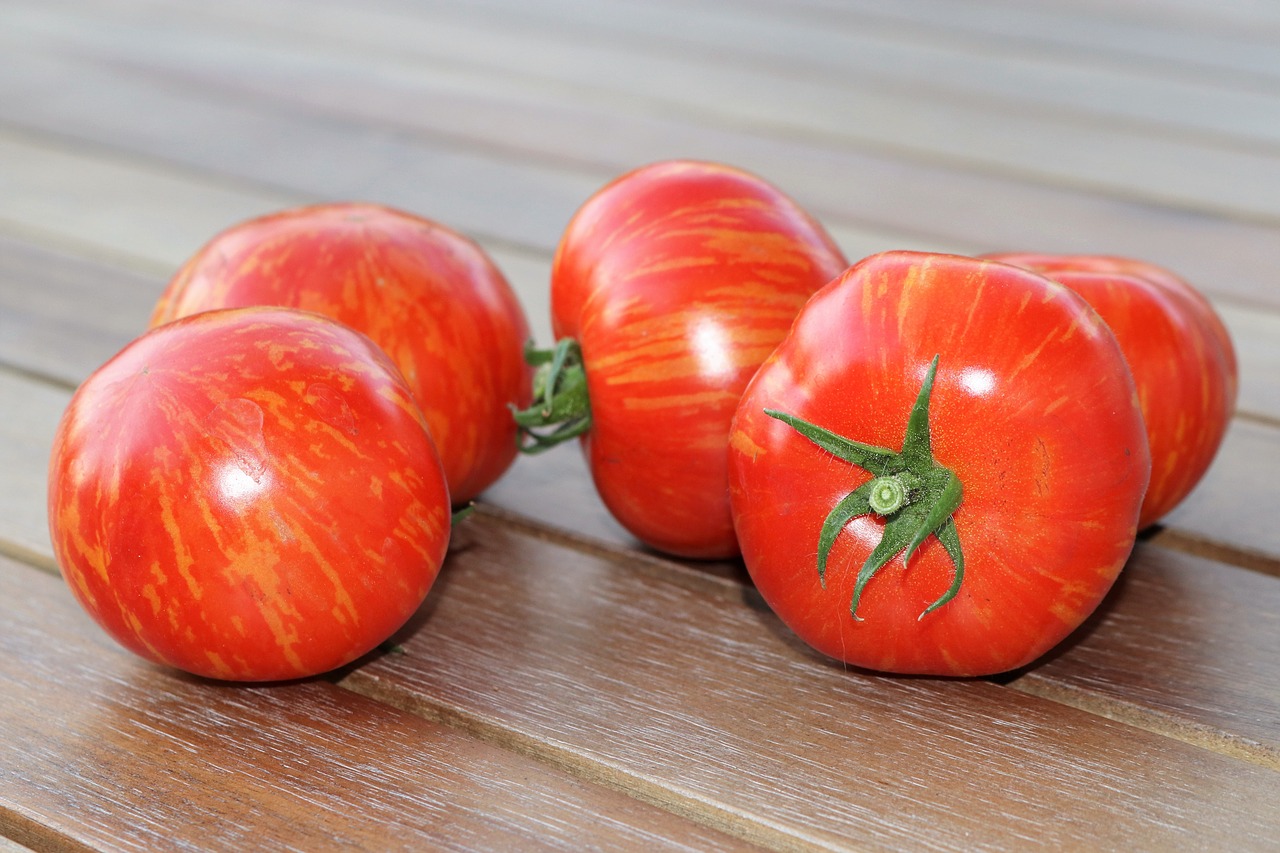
[517, 163, 1236, 676]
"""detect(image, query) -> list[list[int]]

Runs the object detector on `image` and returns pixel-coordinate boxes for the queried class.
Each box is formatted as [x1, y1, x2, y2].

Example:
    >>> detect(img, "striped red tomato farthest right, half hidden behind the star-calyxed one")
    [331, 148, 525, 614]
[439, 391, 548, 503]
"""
[988, 255, 1238, 528]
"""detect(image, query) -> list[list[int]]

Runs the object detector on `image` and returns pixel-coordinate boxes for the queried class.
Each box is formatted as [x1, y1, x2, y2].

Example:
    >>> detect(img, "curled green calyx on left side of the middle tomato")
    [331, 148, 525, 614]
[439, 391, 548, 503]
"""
[511, 338, 591, 455]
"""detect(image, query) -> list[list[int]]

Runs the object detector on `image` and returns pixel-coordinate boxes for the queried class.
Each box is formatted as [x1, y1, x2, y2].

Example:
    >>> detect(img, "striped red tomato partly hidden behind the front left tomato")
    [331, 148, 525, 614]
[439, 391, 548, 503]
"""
[151, 202, 530, 503]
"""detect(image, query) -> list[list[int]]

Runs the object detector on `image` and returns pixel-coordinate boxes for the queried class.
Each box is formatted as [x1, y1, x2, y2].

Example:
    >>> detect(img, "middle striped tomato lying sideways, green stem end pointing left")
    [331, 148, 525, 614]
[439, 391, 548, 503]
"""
[517, 161, 846, 558]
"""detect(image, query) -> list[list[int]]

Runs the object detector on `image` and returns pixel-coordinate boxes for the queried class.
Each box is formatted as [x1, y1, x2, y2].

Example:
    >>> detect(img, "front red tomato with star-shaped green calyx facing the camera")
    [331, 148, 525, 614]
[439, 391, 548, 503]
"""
[730, 252, 1151, 676]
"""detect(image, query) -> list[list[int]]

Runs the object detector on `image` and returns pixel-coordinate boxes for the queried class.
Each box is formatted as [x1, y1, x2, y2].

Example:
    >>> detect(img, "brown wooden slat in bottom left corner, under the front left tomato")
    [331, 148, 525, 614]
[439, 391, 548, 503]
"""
[0, 558, 745, 850]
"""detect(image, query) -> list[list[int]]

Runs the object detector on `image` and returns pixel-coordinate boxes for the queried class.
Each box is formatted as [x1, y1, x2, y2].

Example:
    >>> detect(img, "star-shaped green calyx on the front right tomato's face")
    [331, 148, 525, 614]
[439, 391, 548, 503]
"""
[764, 356, 964, 621]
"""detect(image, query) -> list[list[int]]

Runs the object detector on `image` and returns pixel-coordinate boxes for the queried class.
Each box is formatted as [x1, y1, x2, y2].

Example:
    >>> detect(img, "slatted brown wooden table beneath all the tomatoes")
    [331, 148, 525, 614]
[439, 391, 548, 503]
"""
[0, 0, 1280, 850]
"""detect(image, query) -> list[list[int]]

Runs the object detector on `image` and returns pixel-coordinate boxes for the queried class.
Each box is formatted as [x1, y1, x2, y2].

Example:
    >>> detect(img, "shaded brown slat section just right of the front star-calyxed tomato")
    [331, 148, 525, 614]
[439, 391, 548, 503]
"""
[1012, 544, 1280, 770]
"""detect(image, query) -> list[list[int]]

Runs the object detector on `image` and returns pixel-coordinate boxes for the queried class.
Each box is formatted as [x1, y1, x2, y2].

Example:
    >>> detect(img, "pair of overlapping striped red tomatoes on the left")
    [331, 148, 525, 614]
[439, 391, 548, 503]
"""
[49, 204, 531, 680]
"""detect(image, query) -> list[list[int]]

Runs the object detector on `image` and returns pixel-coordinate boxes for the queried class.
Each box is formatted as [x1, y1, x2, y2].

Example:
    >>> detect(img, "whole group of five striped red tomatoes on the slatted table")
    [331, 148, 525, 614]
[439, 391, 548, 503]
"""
[49, 160, 1236, 680]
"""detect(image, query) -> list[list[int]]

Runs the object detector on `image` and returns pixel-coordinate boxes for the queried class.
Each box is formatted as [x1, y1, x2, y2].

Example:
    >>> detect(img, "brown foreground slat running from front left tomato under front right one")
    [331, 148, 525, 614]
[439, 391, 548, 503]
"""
[343, 517, 1280, 849]
